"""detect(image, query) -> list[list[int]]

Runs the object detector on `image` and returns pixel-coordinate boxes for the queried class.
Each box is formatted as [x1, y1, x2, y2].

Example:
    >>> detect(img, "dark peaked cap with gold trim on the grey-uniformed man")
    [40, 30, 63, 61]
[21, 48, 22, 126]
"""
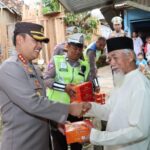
[14, 22, 49, 43]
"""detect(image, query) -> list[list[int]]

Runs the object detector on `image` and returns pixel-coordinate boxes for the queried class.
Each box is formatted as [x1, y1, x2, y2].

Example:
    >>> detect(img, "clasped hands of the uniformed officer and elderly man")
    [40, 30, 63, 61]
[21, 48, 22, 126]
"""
[69, 102, 92, 117]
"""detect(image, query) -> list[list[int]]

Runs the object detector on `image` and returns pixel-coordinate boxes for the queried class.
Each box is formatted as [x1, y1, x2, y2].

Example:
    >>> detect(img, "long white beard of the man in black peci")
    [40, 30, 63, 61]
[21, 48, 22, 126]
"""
[113, 71, 124, 87]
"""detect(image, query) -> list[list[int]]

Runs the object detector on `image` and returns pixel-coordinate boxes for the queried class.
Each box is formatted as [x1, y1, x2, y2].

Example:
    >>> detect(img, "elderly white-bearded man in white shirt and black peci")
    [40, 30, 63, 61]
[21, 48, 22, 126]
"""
[85, 37, 150, 150]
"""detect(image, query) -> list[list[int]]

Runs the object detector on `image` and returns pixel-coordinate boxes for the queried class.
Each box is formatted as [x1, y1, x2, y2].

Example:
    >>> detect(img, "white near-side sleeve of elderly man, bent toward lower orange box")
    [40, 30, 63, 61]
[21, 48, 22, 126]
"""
[90, 90, 150, 146]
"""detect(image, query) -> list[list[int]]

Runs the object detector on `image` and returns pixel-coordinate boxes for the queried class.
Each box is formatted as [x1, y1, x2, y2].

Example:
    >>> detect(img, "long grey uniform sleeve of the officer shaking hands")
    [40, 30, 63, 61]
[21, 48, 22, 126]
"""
[0, 62, 68, 123]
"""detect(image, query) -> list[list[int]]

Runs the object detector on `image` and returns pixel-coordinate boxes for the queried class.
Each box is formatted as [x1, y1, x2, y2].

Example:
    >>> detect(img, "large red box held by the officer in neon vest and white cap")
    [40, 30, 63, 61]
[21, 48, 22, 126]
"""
[71, 82, 94, 102]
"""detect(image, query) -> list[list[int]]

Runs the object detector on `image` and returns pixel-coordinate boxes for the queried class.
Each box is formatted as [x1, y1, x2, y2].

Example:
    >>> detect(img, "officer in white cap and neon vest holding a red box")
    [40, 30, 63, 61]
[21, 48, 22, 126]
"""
[44, 34, 90, 150]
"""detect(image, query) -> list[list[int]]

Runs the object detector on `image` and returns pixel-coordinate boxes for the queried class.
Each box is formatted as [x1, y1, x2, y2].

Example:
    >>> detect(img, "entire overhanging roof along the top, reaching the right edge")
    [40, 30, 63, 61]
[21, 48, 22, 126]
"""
[59, 0, 150, 13]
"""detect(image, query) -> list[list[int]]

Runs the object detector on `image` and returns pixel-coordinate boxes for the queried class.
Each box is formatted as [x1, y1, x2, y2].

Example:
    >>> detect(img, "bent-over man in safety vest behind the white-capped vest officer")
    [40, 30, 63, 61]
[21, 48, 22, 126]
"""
[84, 37, 106, 92]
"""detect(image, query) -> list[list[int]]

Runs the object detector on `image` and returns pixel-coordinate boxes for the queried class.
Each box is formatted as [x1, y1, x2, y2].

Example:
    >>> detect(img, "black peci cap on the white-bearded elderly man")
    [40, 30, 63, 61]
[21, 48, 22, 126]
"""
[106, 37, 133, 53]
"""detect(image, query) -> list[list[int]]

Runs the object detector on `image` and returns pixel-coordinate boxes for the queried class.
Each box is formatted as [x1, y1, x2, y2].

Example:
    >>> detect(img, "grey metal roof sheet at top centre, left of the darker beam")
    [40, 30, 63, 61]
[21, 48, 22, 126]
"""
[59, 0, 114, 13]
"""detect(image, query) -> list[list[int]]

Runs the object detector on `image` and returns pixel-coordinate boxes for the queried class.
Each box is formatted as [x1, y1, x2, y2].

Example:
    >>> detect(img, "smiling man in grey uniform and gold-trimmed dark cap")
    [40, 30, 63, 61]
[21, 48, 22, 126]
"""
[0, 22, 89, 150]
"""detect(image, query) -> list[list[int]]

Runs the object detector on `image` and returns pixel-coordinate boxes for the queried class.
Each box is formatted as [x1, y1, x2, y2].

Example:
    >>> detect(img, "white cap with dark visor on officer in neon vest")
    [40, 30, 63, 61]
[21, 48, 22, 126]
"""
[67, 33, 84, 46]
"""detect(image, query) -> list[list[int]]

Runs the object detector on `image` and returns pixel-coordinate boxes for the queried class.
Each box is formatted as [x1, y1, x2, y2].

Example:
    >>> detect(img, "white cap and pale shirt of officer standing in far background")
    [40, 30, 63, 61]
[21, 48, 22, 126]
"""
[109, 16, 126, 38]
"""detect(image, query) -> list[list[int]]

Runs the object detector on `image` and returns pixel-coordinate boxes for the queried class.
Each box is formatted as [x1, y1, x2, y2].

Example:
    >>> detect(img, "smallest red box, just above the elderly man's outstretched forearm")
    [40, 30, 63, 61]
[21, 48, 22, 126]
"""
[94, 93, 106, 104]
